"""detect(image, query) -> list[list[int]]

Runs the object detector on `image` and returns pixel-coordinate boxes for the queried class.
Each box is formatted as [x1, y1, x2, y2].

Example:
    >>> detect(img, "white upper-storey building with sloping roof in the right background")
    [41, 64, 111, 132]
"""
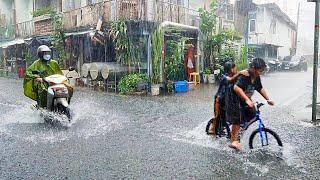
[249, 3, 296, 58]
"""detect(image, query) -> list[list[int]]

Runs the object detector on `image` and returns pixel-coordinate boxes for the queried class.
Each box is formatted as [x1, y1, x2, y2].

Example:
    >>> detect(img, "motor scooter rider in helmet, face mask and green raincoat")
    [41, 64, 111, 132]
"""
[23, 45, 73, 108]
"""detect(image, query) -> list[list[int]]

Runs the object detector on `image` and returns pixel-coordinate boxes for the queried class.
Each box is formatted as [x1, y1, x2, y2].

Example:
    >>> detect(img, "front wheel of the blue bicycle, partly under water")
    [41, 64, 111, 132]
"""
[249, 128, 282, 149]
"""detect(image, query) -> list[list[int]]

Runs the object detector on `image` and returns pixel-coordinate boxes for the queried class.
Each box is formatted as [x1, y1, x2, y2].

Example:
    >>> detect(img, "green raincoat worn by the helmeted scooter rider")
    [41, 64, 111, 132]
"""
[23, 60, 63, 108]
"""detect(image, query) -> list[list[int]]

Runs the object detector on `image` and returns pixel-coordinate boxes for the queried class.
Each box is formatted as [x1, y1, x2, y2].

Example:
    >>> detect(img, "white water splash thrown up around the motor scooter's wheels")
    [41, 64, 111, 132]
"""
[0, 94, 125, 143]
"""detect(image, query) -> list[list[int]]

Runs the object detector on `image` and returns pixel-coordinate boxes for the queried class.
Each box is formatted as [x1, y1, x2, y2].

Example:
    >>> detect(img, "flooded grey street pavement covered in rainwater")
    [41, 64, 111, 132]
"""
[0, 72, 320, 179]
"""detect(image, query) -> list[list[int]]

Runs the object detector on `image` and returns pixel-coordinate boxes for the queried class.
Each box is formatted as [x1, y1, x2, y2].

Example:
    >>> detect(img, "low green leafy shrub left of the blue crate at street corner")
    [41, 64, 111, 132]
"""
[118, 74, 150, 94]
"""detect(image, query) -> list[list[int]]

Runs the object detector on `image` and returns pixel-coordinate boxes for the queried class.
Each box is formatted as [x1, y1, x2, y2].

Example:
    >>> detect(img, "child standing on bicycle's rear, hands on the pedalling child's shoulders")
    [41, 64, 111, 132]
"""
[208, 61, 249, 135]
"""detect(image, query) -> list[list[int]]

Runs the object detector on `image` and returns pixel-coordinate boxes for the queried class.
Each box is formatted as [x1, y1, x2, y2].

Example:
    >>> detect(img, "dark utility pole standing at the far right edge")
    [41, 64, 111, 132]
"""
[308, 0, 319, 123]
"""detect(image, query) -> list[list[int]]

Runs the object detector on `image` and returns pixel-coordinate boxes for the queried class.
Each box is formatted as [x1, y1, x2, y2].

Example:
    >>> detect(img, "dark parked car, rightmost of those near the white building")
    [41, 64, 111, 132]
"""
[281, 56, 308, 71]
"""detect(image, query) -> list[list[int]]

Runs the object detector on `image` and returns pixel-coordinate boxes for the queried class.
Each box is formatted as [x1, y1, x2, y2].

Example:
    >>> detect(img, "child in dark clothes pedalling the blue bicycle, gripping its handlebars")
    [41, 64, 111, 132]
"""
[228, 58, 274, 150]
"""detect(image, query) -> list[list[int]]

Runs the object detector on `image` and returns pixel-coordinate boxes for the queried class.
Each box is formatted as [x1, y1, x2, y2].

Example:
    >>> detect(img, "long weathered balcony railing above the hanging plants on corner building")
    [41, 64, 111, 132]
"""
[63, 0, 198, 30]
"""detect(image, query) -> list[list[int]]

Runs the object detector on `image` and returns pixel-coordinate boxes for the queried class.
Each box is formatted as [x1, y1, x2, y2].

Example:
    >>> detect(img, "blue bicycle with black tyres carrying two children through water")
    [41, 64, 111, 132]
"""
[206, 102, 282, 149]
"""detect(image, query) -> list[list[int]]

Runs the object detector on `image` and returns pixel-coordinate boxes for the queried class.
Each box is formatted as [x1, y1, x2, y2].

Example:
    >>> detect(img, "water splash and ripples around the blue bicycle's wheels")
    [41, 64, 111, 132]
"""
[163, 122, 306, 177]
